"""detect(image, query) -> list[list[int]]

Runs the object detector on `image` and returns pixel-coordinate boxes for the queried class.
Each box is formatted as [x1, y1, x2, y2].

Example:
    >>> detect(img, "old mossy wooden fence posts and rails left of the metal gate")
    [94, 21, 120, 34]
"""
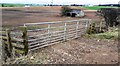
[0, 27, 28, 55]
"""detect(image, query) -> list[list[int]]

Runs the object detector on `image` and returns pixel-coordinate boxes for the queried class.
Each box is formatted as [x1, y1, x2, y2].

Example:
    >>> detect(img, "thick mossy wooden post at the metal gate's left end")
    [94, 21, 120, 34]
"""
[21, 26, 28, 55]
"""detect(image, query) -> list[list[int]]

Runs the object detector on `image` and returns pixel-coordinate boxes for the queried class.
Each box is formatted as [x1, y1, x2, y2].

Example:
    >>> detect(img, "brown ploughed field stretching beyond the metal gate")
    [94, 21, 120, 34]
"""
[0, 6, 99, 26]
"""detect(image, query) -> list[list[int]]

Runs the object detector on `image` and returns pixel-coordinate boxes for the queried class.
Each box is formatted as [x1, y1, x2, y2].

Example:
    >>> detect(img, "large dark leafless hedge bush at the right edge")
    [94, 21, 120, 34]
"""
[97, 8, 119, 28]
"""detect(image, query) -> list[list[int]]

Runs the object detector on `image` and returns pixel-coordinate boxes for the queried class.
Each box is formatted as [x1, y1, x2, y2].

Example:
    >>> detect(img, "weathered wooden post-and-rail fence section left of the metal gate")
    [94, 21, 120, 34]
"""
[0, 27, 28, 55]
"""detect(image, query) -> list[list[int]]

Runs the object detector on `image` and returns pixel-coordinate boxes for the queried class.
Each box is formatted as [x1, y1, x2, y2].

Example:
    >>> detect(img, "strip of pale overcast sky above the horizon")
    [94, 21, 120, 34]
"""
[0, 0, 120, 4]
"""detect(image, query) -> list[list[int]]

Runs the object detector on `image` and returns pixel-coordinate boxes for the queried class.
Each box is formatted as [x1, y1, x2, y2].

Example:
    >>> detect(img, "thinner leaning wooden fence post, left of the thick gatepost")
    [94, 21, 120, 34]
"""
[6, 29, 13, 57]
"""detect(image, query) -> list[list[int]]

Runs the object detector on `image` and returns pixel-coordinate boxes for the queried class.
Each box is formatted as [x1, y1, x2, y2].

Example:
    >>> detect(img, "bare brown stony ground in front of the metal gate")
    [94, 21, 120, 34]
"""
[6, 38, 118, 64]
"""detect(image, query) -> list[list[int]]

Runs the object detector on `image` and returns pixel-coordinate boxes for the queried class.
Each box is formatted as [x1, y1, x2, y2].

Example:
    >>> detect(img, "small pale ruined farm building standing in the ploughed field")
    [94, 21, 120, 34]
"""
[66, 9, 85, 17]
